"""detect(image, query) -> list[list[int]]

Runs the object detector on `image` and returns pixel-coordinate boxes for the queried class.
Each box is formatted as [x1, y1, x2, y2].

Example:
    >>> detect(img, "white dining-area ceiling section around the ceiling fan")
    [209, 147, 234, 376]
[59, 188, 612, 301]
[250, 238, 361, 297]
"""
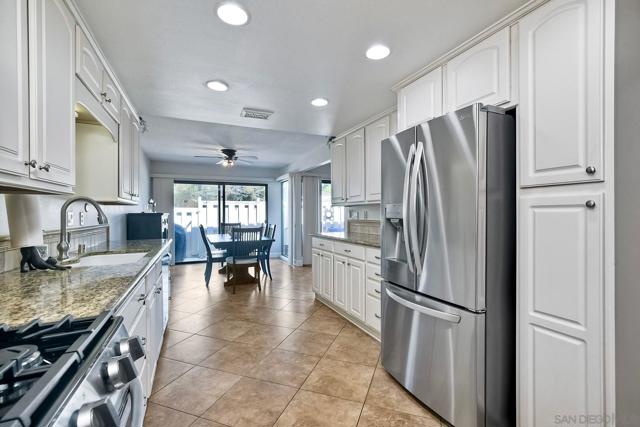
[142, 116, 327, 168]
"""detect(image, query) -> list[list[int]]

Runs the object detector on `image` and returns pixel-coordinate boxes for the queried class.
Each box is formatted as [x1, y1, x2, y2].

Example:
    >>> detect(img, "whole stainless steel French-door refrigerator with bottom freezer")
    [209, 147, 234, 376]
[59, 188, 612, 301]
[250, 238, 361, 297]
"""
[381, 104, 516, 427]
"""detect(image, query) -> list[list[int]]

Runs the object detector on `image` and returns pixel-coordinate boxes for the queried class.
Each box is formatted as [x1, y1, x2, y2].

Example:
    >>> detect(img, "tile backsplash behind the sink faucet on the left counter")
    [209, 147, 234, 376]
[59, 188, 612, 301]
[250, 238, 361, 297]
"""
[0, 224, 109, 273]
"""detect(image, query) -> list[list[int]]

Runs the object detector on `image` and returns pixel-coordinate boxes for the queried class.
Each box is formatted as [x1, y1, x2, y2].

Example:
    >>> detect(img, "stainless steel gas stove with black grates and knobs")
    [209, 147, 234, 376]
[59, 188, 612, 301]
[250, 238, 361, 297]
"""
[0, 313, 145, 427]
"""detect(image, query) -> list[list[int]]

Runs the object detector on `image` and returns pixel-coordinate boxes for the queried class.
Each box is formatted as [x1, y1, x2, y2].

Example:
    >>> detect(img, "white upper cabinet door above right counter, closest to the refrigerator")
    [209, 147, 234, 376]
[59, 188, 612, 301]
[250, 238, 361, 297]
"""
[364, 116, 390, 202]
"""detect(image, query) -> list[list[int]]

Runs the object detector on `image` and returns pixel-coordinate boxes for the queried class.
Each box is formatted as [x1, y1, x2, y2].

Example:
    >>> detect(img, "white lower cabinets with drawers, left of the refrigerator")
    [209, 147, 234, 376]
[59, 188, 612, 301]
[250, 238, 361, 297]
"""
[311, 237, 381, 337]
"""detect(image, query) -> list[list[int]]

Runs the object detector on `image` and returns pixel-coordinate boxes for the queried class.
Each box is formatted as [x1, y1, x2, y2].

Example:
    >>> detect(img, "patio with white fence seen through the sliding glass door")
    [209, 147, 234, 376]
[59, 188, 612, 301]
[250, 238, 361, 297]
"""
[173, 182, 268, 263]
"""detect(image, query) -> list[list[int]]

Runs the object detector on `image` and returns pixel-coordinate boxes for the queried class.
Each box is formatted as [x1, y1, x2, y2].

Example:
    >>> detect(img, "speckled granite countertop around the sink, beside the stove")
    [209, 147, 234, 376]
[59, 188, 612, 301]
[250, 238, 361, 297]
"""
[0, 239, 171, 326]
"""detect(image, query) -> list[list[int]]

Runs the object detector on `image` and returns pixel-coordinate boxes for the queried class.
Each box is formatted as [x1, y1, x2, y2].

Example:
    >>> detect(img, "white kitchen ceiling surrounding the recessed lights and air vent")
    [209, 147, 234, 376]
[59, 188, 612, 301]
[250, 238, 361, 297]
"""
[76, 0, 527, 162]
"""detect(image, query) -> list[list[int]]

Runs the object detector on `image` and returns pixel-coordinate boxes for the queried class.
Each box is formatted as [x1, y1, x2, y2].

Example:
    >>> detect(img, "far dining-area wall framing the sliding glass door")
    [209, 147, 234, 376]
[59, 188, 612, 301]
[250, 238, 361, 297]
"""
[151, 161, 282, 256]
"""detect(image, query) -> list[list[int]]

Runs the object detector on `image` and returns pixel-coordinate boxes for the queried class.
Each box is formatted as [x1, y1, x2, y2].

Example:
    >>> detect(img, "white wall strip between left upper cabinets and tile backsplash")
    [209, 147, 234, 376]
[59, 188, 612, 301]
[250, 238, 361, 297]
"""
[0, 153, 151, 240]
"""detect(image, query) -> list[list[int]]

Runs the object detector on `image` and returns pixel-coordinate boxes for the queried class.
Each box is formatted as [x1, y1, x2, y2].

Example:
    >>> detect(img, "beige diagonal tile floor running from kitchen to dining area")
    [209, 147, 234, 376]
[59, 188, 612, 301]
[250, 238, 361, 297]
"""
[144, 262, 444, 427]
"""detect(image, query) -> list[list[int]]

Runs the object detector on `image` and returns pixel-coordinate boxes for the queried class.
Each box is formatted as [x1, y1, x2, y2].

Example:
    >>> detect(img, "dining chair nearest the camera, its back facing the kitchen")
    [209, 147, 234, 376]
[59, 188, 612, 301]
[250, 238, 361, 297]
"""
[226, 227, 263, 294]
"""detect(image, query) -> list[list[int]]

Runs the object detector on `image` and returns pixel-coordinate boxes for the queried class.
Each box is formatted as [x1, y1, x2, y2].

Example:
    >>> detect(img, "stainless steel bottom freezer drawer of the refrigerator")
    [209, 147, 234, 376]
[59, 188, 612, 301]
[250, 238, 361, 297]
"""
[382, 282, 485, 427]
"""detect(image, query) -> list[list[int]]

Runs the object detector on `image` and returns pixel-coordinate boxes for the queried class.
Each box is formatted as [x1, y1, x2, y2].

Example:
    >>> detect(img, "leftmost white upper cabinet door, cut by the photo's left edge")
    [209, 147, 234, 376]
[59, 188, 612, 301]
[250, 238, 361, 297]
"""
[0, 0, 30, 176]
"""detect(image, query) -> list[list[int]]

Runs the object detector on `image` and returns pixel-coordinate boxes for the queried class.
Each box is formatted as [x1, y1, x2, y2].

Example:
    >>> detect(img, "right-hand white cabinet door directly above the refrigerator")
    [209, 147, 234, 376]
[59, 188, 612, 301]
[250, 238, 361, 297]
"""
[446, 27, 511, 111]
